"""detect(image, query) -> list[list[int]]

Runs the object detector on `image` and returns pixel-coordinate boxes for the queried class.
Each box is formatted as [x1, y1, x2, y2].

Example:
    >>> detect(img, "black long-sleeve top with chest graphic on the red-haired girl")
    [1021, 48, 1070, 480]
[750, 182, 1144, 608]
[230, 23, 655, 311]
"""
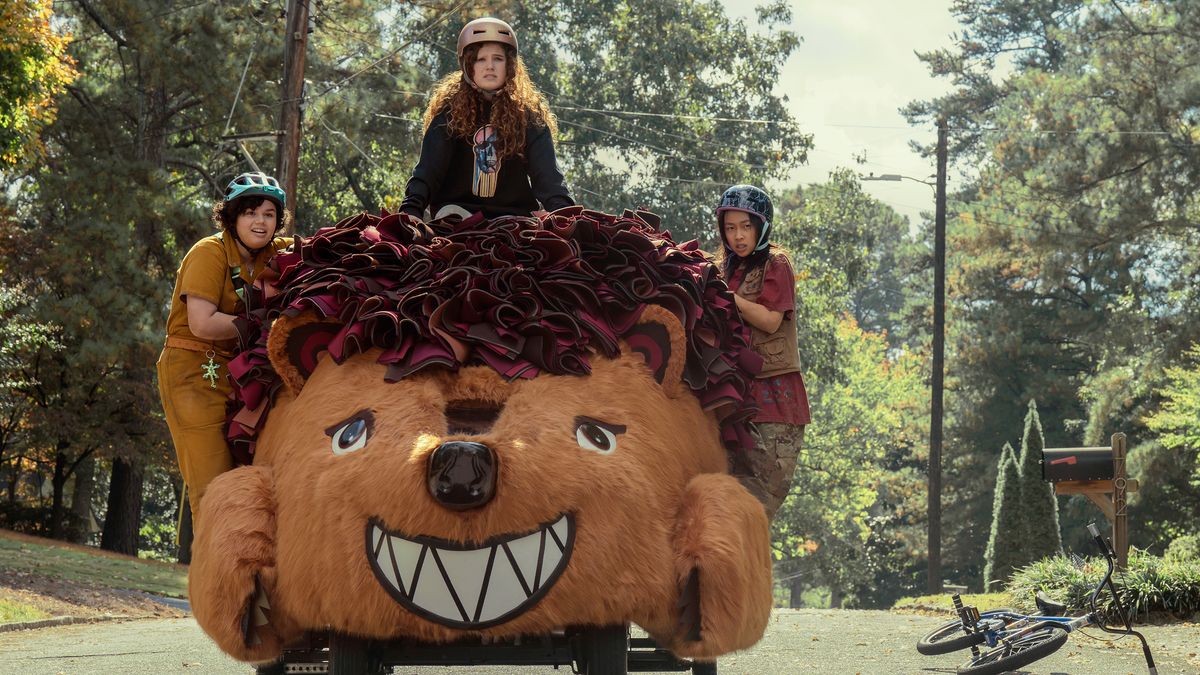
[400, 110, 575, 217]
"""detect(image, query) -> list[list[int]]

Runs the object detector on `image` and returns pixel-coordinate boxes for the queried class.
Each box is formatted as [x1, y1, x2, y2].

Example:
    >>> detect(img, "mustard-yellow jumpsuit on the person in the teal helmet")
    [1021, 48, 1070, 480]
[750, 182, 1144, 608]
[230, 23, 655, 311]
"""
[158, 233, 285, 522]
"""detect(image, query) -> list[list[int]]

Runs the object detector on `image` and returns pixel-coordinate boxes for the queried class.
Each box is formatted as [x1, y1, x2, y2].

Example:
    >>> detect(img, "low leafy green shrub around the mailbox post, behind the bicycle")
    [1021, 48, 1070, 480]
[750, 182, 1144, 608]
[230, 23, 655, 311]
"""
[1008, 549, 1200, 619]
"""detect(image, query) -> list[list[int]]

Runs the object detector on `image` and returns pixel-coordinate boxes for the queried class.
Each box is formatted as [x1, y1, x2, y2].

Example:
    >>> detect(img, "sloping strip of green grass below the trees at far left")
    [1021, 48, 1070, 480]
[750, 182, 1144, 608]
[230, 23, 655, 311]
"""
[0, 530, 187, 595]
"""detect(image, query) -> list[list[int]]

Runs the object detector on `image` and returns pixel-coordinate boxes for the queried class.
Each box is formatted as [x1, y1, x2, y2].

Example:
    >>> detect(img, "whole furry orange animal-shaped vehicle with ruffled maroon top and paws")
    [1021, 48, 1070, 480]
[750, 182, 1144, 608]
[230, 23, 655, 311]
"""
[190, 207, 772, 673]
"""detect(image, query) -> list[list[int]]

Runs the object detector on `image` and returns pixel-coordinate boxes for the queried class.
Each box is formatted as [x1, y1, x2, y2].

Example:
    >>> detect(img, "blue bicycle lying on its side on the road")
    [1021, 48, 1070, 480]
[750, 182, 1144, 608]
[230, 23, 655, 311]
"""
[917, 522, 1158, 675]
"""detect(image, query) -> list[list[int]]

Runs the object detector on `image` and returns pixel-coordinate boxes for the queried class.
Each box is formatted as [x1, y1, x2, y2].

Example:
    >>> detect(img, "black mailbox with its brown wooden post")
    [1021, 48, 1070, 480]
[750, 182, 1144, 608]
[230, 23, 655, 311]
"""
[1042, 434, 1138, 569]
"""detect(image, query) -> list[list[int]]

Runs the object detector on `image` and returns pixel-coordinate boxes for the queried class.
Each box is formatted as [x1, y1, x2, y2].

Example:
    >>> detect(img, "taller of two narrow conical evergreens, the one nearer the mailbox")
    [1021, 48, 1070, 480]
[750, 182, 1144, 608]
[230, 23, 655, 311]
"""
[1018, 400, 1062, 557]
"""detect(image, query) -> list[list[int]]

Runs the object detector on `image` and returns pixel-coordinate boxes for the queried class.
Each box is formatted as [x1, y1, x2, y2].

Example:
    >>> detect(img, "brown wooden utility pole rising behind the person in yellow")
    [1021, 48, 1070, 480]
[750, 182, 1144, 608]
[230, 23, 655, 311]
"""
[275, 0, 308, 220]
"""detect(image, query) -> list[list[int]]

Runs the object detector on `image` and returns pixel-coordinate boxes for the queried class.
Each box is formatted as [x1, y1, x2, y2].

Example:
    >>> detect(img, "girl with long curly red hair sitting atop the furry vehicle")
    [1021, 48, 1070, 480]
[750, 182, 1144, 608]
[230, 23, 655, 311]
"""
[400, 18, 575, 219]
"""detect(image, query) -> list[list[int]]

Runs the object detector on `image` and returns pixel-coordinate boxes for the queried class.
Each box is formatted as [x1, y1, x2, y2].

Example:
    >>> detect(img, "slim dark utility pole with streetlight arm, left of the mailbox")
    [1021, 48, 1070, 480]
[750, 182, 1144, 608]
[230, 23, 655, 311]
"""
[929, 118, 947, 593]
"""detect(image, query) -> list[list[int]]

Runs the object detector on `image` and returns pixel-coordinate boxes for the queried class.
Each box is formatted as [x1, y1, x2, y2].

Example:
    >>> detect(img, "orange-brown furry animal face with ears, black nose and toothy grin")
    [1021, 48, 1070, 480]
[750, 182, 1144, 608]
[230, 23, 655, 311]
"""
[254, 307, 725, 637]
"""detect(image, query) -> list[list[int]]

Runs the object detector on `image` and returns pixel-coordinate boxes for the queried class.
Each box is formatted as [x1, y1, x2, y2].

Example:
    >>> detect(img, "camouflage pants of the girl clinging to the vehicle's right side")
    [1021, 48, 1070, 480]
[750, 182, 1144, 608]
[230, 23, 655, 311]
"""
[731, 423, 804, 520]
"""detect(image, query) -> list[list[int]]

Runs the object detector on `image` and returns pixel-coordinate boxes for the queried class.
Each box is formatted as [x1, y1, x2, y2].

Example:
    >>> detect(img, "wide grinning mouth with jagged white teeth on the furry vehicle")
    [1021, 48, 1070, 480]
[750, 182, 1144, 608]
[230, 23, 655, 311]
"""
[366, 514, 575, 628]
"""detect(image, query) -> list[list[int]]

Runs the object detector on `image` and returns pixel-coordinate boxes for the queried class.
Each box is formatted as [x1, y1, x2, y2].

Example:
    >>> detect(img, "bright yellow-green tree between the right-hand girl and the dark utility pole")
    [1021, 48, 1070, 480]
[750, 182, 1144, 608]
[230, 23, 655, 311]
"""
[774, 316, 928, 607]
